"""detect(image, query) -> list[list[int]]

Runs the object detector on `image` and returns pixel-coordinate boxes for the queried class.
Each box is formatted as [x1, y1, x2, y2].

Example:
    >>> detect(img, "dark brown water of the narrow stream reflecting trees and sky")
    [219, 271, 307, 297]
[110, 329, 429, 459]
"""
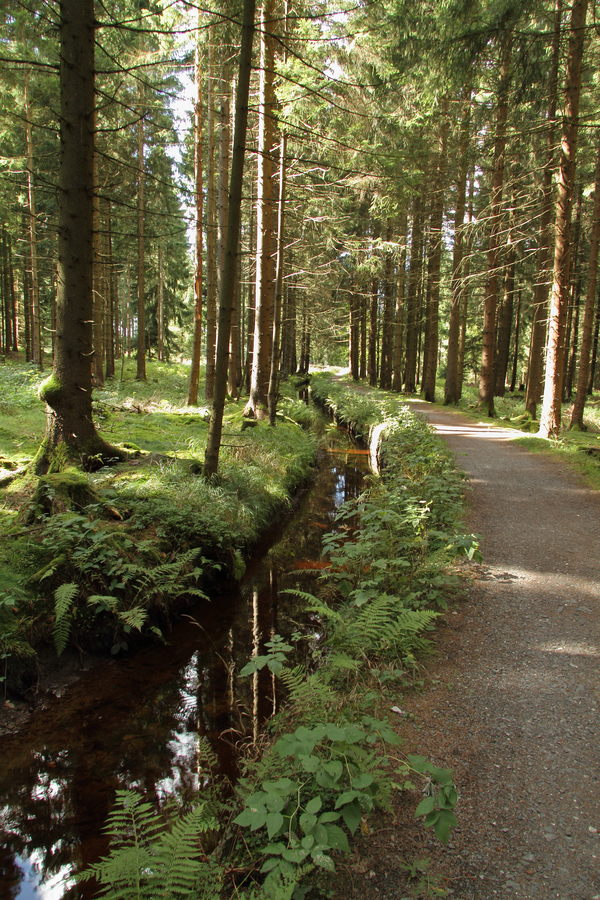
[0, 430, 368, 900]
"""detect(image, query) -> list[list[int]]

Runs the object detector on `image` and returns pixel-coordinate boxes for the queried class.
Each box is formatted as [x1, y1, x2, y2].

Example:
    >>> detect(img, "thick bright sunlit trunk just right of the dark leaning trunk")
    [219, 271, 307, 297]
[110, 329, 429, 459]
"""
[244, 0, 276, 419]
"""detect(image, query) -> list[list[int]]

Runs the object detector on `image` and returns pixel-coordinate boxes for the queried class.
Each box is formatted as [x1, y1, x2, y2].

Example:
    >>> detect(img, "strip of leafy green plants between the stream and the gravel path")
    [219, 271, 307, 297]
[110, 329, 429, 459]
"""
[89, 376, 477, 900]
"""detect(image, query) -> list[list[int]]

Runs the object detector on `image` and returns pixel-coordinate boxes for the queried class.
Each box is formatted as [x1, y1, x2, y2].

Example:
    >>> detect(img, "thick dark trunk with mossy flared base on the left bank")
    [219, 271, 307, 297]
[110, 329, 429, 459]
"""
[35, 0, 122, 473]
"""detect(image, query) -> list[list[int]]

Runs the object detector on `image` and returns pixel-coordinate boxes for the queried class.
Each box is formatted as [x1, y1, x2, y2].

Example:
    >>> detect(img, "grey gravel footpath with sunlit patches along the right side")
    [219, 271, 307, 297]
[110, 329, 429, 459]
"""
[334, 402, 600, 900]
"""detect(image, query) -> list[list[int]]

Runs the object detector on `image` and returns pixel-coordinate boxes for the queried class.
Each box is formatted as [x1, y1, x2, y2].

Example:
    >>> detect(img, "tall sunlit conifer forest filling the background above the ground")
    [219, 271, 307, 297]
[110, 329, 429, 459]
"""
[0, 0, 600, 450]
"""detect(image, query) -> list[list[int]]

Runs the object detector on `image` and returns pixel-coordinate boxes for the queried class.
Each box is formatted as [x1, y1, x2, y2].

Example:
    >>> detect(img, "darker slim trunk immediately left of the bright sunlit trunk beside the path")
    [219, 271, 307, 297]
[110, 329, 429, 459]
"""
[525, 0, 563, 419]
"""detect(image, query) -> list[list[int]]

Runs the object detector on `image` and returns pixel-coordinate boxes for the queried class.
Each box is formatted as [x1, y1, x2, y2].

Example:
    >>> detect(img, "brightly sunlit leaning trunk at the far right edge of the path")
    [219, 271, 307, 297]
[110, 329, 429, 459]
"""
[539, 0, 588, 438]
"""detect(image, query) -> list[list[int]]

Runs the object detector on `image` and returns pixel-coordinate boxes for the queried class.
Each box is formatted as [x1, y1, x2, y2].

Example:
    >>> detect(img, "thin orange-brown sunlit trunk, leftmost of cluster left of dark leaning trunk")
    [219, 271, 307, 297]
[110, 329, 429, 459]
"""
[188, 21, 204, 406]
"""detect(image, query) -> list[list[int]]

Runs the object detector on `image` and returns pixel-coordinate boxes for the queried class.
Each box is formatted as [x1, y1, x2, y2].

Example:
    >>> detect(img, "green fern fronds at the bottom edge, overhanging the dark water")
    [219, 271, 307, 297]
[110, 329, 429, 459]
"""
[79, 791, 222, 900]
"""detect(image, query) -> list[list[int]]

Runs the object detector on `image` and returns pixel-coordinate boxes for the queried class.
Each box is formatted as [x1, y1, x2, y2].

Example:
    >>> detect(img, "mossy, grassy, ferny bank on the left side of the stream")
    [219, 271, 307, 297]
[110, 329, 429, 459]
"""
[0, 363, 317, 689]
